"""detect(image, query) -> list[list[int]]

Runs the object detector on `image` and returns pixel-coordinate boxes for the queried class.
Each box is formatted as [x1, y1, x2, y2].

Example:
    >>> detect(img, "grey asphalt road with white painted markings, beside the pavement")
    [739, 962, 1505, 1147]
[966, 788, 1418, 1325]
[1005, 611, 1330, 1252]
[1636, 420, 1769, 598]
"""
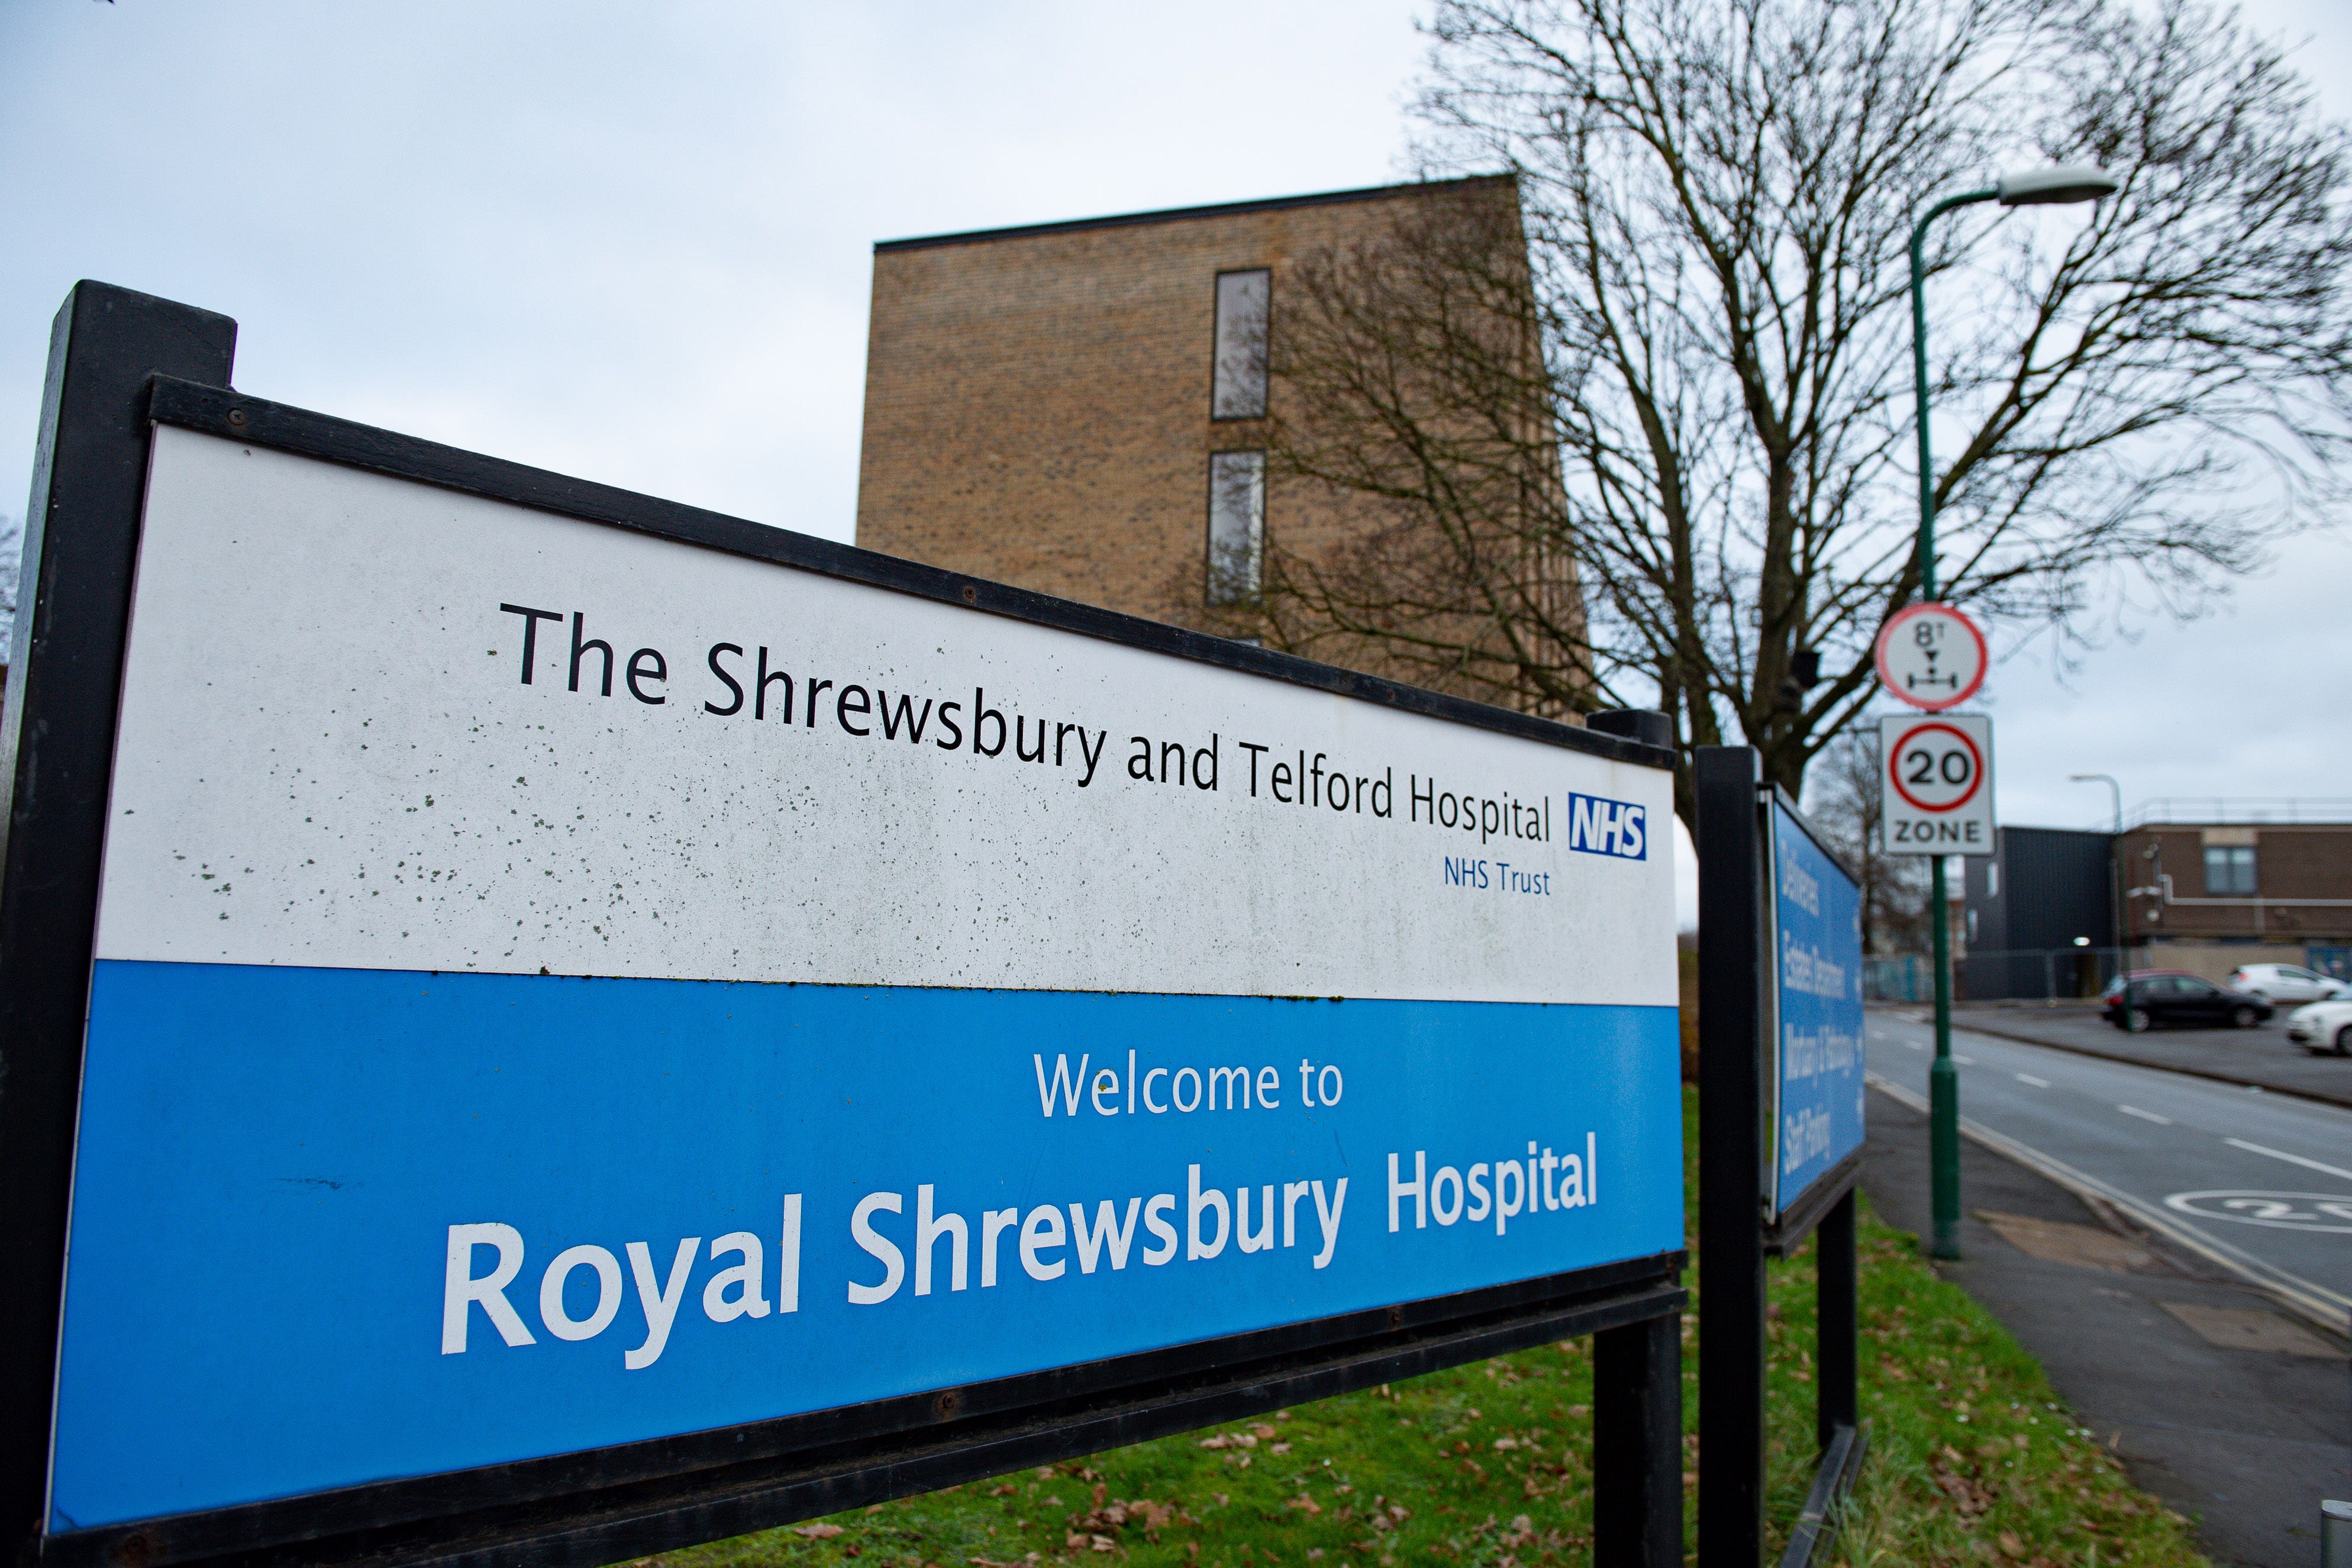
[1865, 1008, 2352, 1324]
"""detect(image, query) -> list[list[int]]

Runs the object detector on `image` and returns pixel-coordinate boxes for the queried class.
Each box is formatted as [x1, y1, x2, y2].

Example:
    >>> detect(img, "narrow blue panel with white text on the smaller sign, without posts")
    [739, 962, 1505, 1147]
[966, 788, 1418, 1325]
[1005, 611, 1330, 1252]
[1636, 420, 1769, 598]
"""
[1766, 799, 1863, 1215]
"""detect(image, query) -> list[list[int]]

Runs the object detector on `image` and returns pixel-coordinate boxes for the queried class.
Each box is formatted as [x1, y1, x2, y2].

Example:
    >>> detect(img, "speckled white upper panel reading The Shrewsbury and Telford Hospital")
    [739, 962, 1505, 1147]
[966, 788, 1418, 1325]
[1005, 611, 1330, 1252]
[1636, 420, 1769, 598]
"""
[99, 428, 1677, 1006]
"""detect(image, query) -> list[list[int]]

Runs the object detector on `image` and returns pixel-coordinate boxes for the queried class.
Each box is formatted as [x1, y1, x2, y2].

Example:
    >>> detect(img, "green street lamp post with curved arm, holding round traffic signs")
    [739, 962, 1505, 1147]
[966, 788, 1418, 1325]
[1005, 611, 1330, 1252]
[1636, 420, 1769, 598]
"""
[1912, 164, 2117, 1258]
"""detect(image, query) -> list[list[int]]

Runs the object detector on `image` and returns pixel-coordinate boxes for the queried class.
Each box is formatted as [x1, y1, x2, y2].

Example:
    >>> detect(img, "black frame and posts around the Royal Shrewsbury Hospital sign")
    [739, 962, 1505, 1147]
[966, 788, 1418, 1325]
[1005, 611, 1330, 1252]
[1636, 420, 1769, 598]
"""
[0, 282, 1686, 1568]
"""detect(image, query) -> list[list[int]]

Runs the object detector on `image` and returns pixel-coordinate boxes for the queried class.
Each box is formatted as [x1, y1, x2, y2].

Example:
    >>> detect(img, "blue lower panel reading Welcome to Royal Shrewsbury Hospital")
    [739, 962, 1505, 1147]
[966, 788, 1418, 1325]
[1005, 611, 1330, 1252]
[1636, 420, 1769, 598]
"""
[51, 962, 1682, 1530]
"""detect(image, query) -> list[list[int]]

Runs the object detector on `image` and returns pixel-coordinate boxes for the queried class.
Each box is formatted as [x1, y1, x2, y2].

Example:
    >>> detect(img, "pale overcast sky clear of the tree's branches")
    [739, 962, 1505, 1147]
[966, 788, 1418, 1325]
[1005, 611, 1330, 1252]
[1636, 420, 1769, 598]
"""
[0, 0, 2352, 921]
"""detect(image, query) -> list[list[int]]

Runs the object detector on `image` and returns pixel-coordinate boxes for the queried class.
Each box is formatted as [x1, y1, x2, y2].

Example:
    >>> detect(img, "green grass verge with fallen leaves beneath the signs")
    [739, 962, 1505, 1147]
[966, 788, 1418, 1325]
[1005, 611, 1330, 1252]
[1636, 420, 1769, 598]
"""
[647, 1098, 2204, 1568]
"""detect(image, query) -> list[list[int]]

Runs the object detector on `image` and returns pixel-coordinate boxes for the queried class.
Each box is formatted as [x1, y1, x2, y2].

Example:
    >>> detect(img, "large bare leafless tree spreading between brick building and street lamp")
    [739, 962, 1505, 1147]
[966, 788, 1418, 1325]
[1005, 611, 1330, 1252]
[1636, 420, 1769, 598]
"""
[1249, 0, 2352, 818]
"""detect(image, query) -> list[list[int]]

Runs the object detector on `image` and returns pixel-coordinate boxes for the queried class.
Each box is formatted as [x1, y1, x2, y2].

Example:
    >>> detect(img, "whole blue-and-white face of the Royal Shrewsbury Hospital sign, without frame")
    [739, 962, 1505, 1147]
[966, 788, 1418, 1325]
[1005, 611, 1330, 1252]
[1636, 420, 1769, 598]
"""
[49, 428, 1684, 1530]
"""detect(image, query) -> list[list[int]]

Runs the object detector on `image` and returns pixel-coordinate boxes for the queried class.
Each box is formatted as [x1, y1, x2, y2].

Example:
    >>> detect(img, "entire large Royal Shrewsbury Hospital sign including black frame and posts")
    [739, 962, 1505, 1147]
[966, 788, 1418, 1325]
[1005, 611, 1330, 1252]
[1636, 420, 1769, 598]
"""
[0, 285, 1684, 1568]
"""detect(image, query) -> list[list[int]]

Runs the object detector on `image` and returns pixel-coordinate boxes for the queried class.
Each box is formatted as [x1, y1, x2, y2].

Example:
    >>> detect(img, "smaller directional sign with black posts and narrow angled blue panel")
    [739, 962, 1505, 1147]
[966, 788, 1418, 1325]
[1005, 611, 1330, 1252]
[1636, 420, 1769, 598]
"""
[1698, 747, 1865, 1568]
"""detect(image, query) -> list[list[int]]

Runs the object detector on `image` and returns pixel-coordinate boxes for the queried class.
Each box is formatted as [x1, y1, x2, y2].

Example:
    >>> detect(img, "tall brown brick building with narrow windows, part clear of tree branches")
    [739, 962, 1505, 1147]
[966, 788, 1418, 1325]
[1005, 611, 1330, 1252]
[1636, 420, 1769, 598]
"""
[856, 176, 1573, 700]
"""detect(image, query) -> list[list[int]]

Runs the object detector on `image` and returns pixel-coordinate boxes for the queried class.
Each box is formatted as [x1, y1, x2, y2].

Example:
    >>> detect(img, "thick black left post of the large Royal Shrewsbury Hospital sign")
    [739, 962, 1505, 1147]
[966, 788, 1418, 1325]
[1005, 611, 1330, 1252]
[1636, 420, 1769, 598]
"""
[0, 282, 237, 1528]
